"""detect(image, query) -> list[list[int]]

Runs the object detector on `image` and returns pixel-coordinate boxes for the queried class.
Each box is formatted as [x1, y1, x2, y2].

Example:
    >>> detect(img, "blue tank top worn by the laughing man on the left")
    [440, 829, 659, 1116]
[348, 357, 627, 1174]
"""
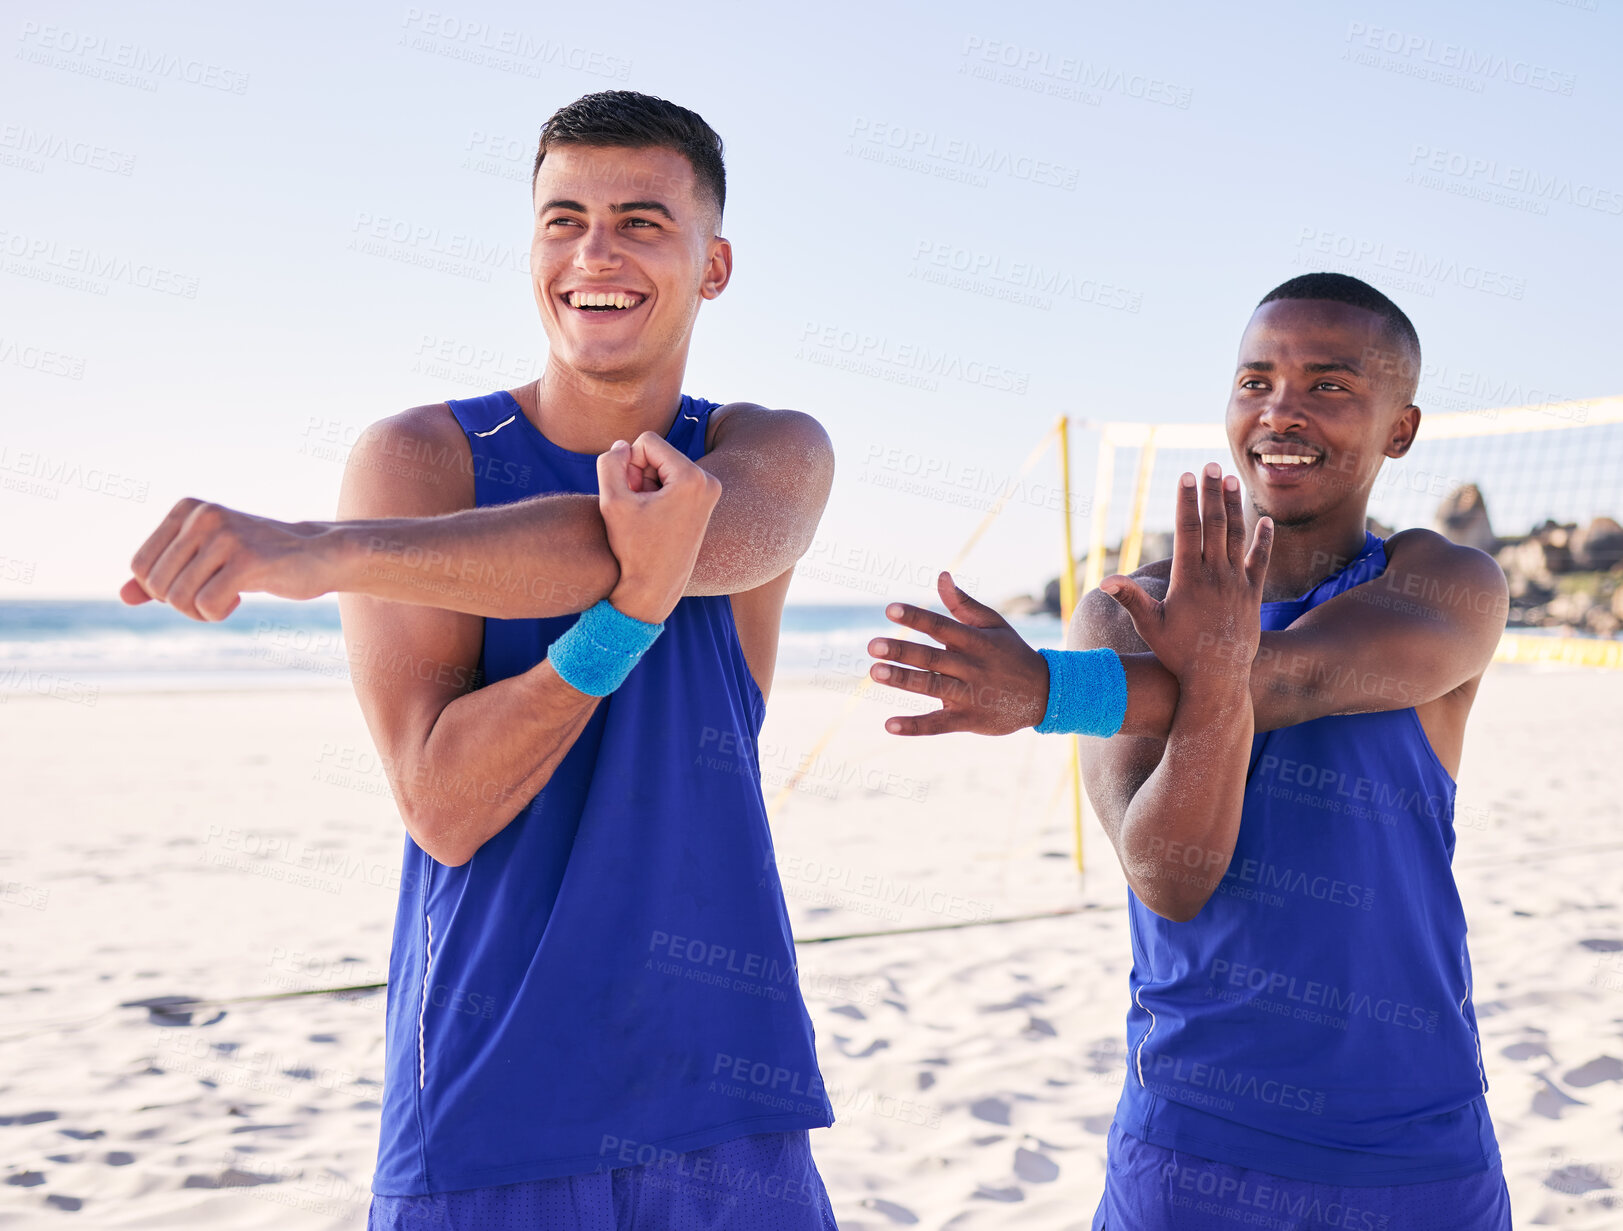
[373, 391, 834, 1195]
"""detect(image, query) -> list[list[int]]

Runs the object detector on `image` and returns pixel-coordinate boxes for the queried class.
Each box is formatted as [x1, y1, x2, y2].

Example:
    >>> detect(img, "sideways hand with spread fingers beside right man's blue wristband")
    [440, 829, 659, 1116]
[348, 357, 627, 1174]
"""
[868, 573, 1048, 736]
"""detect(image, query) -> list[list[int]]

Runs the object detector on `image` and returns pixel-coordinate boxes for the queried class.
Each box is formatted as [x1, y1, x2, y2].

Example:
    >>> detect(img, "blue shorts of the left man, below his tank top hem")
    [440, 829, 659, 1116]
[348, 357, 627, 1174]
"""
[367, 1130, 837, 1231]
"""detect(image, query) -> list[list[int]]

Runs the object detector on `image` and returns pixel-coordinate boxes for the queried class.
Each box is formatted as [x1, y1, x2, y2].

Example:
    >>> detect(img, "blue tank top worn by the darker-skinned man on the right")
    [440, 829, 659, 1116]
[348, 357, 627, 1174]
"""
[1117, 534, 1498, 1186]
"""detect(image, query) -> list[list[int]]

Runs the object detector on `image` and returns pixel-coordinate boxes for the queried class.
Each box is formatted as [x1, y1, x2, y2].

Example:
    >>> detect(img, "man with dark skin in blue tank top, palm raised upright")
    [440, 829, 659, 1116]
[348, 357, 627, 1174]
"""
[868, 274, 1509, 1231]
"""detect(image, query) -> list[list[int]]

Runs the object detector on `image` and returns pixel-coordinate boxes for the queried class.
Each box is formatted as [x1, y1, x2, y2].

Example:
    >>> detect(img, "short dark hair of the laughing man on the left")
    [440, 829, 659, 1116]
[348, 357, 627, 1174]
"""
[529, 89, 727, 222]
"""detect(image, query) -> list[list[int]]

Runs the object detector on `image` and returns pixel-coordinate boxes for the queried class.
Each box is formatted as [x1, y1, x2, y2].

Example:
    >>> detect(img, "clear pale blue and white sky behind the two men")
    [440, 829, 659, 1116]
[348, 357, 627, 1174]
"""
[0, 0, 1623, 603]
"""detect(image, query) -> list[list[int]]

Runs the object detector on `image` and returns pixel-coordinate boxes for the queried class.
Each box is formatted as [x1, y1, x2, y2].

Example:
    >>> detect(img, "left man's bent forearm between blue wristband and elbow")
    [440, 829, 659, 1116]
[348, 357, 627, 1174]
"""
[393, 661, 597, 866]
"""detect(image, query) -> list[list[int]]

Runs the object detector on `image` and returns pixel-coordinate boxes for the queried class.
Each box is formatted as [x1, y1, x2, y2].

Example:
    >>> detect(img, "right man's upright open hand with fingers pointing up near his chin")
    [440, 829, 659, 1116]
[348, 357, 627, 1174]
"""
[1099, 463, 1274, 692]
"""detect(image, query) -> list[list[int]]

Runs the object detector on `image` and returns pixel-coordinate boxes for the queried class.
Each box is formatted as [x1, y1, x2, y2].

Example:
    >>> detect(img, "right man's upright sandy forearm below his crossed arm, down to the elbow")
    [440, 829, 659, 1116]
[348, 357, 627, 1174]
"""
[1118, 684, 1253, 921]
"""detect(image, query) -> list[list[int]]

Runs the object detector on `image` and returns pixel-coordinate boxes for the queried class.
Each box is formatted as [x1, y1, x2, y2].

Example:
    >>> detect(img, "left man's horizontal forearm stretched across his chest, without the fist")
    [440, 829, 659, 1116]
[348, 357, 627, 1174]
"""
[313, 494, 620, 620]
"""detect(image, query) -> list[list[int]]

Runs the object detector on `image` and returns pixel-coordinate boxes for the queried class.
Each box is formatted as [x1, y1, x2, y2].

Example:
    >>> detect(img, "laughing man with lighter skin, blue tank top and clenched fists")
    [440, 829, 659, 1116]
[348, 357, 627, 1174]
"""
[123, 91, 834, 1231]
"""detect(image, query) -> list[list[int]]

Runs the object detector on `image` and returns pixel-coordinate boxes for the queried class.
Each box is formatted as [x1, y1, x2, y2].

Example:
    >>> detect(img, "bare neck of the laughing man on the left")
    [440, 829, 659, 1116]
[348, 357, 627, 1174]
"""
[513, 357, 682, 453]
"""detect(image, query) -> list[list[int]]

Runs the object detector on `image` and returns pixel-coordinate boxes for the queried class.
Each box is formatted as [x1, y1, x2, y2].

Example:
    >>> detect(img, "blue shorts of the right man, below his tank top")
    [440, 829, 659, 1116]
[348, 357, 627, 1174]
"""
[1092, 1124, 1511, 1231]
